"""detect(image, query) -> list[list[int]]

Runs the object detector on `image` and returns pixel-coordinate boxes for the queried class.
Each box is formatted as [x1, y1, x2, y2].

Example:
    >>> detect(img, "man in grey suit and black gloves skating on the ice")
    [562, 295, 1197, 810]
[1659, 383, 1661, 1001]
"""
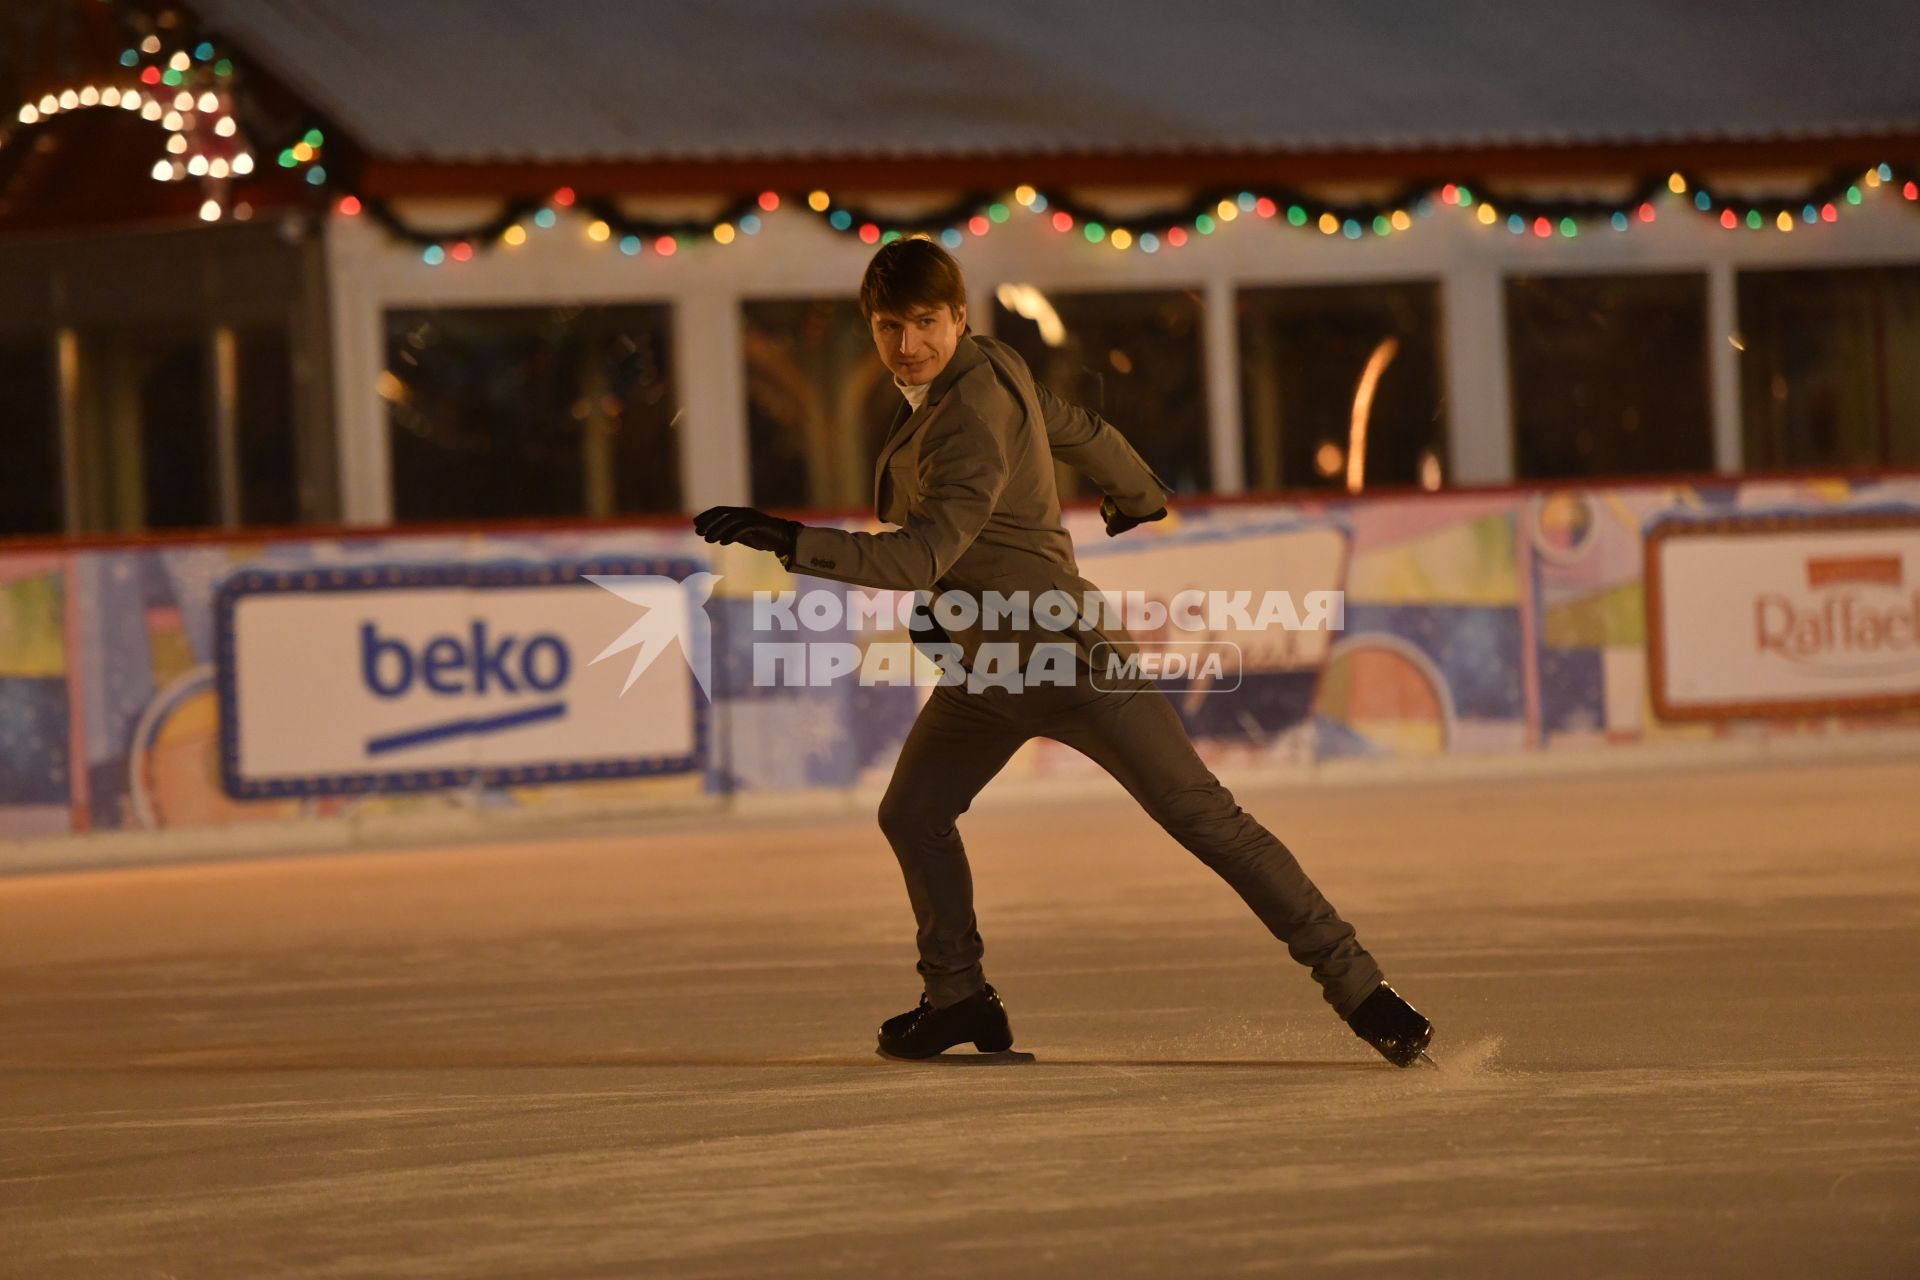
[693, 238, 1432, 1067]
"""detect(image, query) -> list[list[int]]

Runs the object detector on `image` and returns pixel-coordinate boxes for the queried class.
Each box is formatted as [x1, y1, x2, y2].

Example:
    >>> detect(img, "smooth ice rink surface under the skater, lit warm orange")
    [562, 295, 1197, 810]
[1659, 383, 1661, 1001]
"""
[0, 758, 1920, 1280]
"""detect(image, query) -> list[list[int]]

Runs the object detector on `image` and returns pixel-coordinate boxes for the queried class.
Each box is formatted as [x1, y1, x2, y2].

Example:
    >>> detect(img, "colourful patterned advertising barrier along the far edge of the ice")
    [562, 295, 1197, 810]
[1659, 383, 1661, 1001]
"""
[0, 476, 1920, 862]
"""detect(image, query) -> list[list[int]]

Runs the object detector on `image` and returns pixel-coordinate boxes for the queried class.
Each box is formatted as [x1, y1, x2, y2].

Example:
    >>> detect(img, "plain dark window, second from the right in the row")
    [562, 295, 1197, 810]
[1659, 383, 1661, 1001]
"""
[1507, 274, 1713, 480]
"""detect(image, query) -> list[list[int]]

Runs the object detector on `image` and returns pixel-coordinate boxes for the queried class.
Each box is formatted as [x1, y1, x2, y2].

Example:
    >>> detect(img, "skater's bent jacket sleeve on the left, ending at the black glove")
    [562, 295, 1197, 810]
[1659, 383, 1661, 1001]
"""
[785, 405, 1006, 591]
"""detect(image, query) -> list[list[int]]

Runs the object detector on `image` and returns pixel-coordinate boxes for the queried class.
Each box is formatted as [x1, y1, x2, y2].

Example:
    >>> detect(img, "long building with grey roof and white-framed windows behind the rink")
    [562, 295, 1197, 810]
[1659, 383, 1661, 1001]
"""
[0, 0, 1920, 533]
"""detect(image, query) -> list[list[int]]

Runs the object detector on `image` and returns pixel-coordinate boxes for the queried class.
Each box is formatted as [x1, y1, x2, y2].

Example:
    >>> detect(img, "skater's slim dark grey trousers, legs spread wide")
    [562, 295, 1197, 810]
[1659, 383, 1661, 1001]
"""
[879, 668, 1382, 1017]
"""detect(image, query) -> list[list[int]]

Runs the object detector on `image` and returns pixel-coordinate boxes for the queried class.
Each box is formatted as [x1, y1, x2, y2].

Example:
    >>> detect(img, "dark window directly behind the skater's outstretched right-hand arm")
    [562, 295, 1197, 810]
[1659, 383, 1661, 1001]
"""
[993, 284, 1213, 499]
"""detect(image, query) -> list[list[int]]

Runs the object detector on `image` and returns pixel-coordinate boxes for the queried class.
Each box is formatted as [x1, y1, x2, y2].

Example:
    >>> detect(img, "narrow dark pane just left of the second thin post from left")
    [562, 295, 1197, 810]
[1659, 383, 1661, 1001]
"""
[129, 340, 221, 530]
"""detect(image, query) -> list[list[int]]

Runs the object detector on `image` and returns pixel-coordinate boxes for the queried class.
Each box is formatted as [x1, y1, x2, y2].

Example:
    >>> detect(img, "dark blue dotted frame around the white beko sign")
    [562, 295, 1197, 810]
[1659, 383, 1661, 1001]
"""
[213, 558, 712, 800]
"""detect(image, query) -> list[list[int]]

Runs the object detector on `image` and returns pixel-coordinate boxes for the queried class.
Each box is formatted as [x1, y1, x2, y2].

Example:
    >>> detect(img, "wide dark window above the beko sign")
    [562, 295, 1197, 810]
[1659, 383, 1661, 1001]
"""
[382, 305, 680, 520]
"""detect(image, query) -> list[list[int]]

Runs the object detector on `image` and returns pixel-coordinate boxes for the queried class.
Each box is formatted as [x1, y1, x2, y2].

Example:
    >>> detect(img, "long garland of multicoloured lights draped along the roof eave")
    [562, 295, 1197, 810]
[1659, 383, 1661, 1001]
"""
[349, 165, 1920, 267]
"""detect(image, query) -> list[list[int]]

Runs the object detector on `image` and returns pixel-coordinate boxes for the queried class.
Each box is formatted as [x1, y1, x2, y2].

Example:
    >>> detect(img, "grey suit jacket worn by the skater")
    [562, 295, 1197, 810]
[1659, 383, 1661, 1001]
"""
[787, 336, 1173, 668]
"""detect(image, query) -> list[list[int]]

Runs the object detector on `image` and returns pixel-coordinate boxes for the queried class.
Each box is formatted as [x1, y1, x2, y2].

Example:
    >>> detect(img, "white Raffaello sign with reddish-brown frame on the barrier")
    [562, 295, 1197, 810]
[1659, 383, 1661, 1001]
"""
[1647, 514, 1920, 720]
